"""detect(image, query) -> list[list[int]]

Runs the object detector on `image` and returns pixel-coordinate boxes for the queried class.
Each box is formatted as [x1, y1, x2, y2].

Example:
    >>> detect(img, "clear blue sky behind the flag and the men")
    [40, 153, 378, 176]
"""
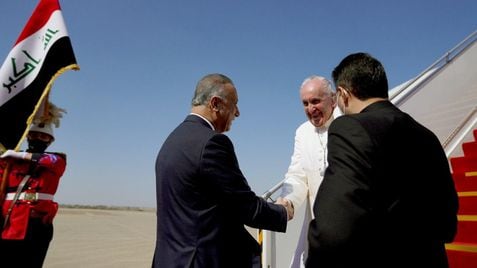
[0, 0, 477, 207]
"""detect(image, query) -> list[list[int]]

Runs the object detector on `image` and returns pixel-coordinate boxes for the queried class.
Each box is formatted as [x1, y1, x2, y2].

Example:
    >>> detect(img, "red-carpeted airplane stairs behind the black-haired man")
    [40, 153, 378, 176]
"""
[446, 129, 477, 268]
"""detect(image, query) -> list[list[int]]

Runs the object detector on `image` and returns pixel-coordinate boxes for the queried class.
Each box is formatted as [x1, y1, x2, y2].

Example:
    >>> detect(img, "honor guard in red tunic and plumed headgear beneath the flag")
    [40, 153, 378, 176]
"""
[0, 103, 66, 268]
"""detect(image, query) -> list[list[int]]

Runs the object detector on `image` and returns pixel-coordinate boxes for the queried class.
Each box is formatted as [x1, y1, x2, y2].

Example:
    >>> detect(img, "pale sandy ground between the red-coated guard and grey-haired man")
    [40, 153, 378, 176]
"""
[43, 207, 156, 268]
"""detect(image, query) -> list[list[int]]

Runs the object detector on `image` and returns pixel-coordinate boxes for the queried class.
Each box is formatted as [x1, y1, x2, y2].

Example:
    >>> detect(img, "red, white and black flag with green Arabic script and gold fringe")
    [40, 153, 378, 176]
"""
[0, 0, 79, 150]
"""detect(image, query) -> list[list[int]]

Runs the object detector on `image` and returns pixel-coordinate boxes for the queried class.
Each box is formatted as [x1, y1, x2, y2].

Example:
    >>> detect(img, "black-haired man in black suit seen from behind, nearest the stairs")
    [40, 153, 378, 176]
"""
[306, 53, 458, 268]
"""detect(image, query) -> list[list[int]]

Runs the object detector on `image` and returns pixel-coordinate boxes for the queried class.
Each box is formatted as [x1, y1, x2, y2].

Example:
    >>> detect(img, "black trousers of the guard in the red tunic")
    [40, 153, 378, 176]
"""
[0, 218, 53, 268]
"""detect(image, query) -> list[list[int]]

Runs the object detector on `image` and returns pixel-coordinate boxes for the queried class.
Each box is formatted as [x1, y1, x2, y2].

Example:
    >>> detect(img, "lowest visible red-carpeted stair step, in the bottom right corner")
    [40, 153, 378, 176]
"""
[446, 243, 477, 268]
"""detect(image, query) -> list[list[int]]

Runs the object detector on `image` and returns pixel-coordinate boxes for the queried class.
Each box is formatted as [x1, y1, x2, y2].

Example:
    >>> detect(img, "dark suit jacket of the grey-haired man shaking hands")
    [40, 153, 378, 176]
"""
[153, 115, 287, 268]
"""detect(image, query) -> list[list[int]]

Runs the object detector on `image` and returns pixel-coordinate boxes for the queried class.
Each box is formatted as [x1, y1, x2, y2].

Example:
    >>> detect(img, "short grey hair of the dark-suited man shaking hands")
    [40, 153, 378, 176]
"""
[192, 73, 233, 106]
